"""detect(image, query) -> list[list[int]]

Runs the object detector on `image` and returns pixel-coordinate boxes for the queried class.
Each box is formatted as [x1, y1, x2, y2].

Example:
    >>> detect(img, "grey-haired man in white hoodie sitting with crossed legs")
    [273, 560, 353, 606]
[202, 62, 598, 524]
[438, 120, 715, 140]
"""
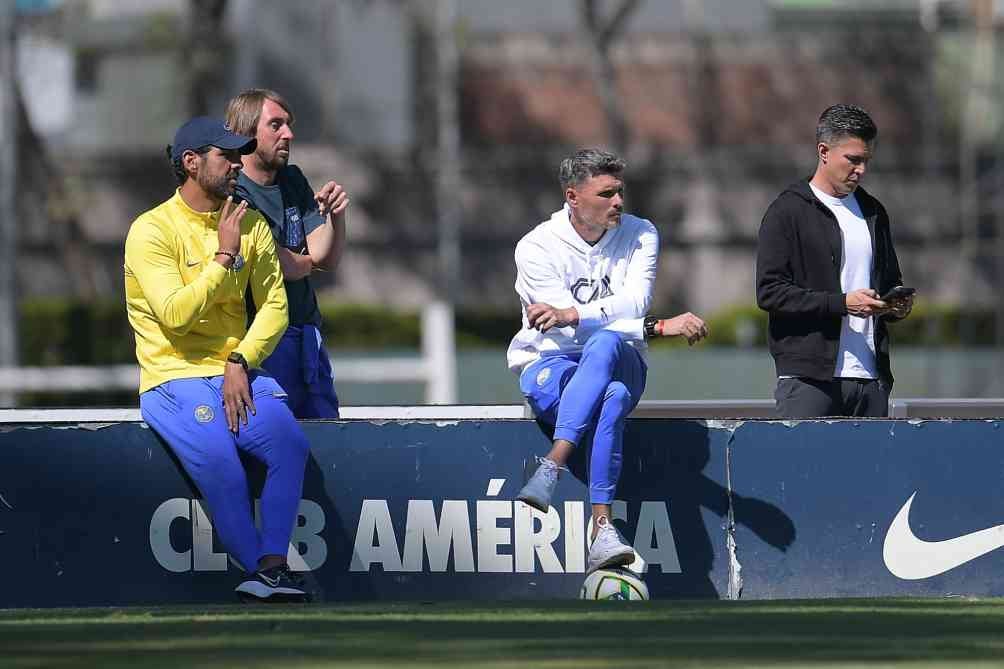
[508, 149, 708, 572]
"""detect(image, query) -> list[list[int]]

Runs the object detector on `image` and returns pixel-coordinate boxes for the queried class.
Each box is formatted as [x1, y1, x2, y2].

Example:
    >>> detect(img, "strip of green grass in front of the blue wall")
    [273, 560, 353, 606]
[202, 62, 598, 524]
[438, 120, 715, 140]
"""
[0, 599, 1004, 669]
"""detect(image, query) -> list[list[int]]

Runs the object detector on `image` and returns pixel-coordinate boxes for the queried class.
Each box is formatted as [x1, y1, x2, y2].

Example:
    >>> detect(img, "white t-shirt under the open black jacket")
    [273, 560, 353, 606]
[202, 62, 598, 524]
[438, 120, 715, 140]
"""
[809, 184, 879, 379]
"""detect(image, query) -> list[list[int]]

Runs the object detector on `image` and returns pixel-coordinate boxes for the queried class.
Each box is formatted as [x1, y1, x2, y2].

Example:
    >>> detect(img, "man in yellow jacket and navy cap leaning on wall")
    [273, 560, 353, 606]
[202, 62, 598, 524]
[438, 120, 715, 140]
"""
[126, 117, 309, 601]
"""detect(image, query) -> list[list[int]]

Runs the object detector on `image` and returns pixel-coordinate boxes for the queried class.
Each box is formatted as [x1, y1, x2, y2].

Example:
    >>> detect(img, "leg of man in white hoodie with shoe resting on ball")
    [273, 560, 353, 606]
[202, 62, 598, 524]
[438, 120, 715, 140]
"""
[587, 347, 648, 572]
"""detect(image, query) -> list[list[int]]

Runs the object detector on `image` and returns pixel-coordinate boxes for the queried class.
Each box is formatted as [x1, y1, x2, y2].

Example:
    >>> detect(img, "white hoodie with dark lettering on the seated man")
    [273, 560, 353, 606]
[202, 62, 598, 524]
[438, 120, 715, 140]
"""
[507, 205, 659, 374]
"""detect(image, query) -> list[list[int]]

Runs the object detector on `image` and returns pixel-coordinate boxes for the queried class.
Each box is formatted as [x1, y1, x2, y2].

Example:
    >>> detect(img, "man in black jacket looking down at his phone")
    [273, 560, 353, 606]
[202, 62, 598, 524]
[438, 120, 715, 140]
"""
[756, 104, 913, 418]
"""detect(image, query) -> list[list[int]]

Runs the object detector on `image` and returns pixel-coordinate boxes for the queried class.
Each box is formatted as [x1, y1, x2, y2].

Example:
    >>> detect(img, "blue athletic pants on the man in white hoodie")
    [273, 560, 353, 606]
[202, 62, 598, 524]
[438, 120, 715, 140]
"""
[519, 329, 648, 504]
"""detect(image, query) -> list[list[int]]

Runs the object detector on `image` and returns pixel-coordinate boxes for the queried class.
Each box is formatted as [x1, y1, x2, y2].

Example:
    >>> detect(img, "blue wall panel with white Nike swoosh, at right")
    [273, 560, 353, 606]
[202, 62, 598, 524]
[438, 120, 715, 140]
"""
[732, 421, 1004, 598]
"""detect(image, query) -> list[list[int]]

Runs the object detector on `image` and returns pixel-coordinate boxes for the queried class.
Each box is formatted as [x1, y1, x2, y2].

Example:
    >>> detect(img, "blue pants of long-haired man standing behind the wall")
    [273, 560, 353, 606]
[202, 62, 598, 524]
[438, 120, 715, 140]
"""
[261, 325, 338, 418]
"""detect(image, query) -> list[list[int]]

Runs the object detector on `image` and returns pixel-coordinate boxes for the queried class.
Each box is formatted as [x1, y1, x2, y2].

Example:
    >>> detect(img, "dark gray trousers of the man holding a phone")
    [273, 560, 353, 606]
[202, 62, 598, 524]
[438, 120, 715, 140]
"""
[774, 378, 889, 418]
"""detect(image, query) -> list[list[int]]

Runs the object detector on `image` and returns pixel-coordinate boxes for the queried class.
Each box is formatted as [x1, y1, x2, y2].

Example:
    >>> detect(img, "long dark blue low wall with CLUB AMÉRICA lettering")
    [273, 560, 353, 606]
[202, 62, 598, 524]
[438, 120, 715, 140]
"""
[0, 420, 1004, 607]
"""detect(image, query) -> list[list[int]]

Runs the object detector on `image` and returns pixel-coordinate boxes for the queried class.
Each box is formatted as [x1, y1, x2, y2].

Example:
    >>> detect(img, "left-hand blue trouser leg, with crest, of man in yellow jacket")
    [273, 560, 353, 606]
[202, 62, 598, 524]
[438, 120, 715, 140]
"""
[140, 379, 260, 572]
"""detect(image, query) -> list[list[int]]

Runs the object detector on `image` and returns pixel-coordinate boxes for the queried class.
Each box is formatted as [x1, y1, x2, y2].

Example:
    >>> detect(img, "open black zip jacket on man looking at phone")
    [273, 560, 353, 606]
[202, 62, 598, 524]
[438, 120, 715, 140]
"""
[756, 180, 903, 388]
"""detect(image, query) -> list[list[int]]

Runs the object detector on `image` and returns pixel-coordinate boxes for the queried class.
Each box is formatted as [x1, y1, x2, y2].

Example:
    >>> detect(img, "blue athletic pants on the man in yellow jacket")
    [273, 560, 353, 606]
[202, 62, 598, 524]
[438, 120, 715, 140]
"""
[140, 372, 309, 572]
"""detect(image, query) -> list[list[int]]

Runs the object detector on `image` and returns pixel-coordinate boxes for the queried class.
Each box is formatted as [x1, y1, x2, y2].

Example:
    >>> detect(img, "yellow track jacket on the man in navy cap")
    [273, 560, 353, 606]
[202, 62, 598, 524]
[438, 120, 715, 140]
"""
[126, 192, 288, 393]
